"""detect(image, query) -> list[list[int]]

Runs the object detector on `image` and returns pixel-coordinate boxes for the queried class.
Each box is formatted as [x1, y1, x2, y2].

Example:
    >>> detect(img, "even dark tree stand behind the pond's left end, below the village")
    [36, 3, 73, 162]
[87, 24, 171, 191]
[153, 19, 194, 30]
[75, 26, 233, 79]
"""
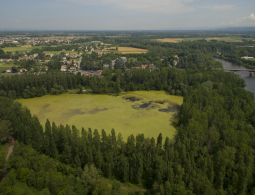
[0, 72, 89, 99]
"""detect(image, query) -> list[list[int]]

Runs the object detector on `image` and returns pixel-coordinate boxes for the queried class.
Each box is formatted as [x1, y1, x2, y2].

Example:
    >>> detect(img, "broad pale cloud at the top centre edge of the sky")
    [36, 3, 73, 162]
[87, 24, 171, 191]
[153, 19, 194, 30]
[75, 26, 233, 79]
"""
[60, 0, 195, 14]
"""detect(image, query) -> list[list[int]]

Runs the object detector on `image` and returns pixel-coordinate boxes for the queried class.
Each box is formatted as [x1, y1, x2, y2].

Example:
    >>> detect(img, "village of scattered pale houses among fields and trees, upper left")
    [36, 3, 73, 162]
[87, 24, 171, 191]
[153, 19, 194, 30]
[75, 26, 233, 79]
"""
[0, 37, 183, 77]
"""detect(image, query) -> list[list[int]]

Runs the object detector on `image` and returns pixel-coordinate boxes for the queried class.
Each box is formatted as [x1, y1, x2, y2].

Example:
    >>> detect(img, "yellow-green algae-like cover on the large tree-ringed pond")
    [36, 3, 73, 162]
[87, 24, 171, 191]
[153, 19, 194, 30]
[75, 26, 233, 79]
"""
[17, 91, 183, 140]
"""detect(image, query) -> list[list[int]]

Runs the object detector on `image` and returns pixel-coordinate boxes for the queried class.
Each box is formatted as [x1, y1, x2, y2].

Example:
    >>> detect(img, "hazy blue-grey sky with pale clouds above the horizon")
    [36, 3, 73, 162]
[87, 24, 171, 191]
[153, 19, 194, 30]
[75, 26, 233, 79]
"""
[0, 0, 255, 30]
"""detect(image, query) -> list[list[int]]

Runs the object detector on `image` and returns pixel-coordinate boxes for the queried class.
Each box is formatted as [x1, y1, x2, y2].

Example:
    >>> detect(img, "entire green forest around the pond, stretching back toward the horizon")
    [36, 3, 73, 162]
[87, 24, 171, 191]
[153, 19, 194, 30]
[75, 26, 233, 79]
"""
[0, 32, 255, 195]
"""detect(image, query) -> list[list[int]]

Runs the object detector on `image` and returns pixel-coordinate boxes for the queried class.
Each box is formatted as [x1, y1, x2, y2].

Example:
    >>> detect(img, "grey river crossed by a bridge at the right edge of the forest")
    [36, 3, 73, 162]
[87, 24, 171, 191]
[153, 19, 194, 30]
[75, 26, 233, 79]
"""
[214, 58, 255, 94]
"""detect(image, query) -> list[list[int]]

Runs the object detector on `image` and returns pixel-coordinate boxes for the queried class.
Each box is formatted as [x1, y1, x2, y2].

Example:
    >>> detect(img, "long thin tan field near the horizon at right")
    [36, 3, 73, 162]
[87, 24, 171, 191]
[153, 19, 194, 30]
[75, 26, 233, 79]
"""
[152, 37, 252, 43]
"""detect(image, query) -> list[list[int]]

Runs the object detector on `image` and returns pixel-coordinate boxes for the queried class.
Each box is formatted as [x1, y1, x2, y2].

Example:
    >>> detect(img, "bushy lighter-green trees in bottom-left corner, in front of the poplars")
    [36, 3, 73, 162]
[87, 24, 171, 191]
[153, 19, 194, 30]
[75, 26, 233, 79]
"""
[0, 142, 139, 195]
